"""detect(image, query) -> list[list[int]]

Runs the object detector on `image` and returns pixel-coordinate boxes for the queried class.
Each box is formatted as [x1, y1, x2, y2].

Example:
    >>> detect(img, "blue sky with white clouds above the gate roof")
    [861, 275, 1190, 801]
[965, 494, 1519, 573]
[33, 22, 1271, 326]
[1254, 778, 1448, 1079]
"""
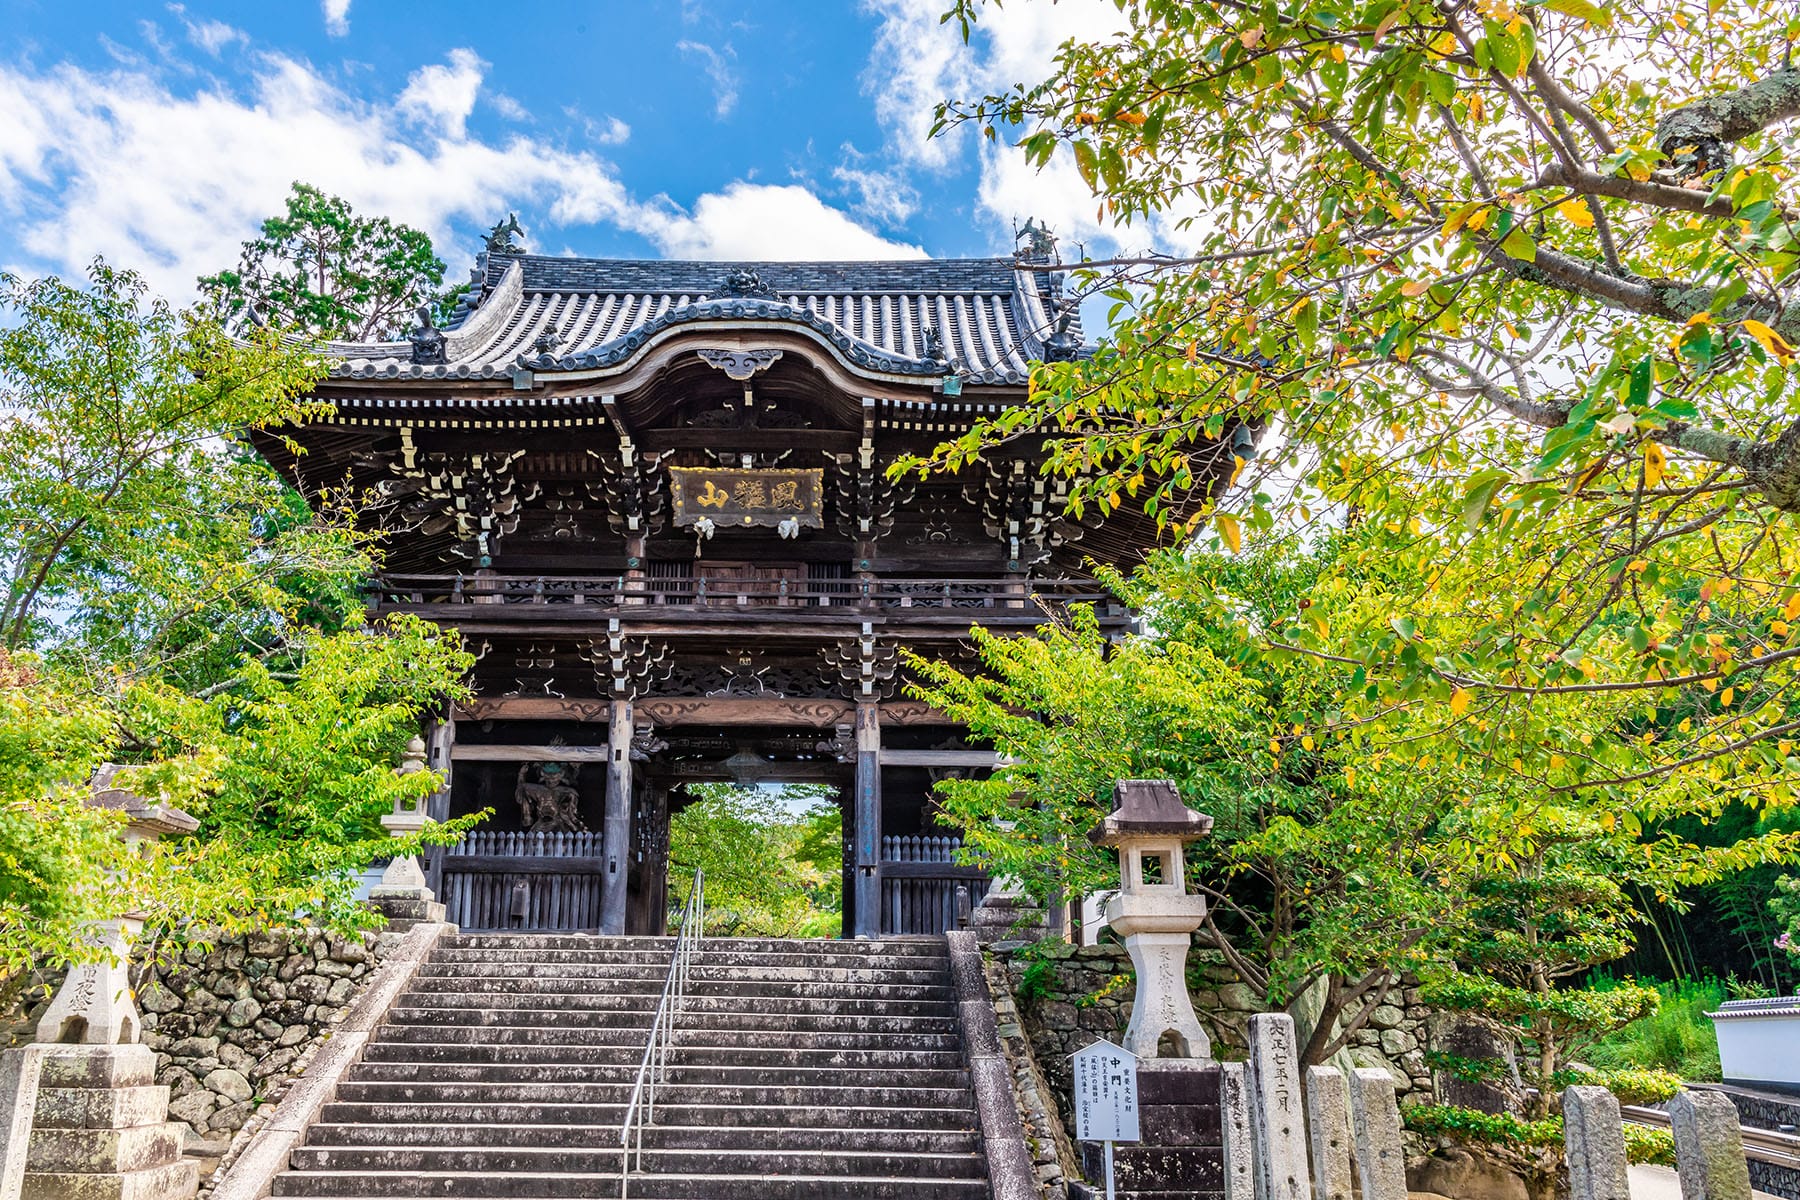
[0, 0, 1143, 299]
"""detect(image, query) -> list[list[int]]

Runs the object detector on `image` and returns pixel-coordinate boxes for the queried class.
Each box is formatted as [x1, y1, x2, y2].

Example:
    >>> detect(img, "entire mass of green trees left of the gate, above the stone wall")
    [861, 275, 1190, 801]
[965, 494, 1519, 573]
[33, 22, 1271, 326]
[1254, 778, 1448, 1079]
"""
[0, 263, 472, 1000]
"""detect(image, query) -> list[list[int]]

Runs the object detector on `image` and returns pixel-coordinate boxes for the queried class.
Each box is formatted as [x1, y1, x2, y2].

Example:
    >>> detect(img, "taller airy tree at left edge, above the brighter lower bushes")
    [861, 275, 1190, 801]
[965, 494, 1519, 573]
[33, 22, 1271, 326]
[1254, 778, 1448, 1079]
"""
[0, 263, 349, 675]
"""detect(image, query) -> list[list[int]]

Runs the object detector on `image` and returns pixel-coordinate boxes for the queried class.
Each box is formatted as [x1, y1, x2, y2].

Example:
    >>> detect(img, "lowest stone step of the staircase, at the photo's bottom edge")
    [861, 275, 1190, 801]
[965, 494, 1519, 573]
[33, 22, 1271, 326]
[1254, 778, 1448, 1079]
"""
[274, 1171, 988, 1200]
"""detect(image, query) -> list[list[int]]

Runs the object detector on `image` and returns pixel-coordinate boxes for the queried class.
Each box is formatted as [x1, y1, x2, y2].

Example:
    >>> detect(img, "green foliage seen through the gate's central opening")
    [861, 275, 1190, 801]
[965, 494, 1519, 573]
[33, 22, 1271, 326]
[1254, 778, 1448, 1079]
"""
[670, 783, 842, 937]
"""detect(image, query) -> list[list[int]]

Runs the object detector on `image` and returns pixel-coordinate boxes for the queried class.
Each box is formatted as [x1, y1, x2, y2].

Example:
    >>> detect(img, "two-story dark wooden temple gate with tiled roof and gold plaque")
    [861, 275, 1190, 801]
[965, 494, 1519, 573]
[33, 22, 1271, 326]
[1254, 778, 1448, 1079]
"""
[254, 234, 1233, 936]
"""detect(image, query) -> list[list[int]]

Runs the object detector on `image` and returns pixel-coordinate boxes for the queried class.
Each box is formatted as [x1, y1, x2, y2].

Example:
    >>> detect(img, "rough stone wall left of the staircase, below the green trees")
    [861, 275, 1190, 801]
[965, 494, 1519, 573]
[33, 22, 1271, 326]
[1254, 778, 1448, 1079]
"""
[11, 930, 396, 1159]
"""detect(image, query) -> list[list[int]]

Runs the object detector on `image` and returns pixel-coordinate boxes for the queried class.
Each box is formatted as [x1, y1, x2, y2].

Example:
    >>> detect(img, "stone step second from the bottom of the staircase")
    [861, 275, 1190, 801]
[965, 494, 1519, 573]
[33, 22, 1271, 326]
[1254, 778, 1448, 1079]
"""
[290, 1144, 986, 1178]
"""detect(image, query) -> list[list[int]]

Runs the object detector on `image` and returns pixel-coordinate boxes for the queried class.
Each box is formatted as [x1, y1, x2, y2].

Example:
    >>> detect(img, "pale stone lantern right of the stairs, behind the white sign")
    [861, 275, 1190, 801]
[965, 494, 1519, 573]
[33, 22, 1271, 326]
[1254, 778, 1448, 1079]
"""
[1087, 779, 1213, 1061]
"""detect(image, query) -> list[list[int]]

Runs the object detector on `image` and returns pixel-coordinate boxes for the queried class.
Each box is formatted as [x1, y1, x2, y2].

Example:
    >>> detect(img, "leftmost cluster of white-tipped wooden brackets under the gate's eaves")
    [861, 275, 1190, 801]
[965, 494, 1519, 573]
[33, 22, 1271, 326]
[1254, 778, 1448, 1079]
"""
[376, 446, 538, 567]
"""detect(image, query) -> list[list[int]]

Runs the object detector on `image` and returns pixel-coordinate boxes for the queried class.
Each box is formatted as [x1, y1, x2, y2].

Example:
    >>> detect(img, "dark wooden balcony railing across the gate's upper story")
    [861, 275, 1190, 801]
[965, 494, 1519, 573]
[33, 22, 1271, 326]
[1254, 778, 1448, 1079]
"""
[369, 572, 1118, 617]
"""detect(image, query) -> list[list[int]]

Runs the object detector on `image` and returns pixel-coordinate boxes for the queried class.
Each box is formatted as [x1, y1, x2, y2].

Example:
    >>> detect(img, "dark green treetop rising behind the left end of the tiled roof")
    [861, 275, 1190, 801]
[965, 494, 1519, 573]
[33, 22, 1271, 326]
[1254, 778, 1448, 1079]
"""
[200, 184, 461, 342]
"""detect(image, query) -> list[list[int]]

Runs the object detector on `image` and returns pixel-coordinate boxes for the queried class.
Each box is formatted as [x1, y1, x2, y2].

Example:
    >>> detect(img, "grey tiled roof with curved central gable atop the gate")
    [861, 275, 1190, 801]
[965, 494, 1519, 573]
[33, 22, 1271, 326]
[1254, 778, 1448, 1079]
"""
[326, 254, 1082, 385]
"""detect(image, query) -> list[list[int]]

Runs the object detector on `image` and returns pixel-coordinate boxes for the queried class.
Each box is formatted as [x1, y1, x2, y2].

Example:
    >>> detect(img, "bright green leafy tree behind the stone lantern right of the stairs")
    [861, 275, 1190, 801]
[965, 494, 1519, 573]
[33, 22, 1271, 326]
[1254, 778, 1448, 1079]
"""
[914, 536, 1796, 1072]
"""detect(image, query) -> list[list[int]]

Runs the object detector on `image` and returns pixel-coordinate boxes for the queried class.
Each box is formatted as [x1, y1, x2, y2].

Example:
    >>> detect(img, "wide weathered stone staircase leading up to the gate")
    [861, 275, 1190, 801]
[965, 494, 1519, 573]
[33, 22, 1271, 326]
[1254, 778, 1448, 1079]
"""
[274, 934, 988, 1200]
